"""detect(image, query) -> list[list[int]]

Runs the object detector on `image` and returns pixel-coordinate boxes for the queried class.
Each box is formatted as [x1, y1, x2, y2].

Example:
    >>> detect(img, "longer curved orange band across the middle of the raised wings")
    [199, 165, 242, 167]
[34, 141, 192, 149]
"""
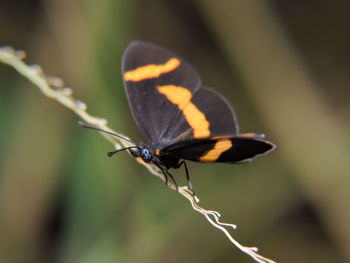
[157, 85, 210, 138]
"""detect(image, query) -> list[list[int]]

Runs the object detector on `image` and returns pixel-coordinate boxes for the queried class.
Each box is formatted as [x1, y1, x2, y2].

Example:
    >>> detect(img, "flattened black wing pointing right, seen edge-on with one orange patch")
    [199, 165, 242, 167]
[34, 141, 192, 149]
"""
[160, 133, 276, 163]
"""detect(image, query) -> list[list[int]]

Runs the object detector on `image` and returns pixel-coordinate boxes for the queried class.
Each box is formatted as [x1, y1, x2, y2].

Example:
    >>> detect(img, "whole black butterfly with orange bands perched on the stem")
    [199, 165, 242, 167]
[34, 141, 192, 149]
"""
[78, 40, 276, 193]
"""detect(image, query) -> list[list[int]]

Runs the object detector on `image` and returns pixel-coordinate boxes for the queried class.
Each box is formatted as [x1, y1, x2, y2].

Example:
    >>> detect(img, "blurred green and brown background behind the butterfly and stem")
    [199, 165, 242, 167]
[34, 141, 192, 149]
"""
[0, 0, 350, 263]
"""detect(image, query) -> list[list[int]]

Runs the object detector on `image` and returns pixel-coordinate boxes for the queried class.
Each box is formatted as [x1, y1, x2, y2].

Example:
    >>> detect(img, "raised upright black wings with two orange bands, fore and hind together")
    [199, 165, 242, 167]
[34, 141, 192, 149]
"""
[123, 41, 238, 149]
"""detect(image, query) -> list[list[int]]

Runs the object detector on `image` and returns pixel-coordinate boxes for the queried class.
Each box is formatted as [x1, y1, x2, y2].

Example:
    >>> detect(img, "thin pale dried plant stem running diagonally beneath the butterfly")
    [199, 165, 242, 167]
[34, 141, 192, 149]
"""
[0, 47, 275, 263]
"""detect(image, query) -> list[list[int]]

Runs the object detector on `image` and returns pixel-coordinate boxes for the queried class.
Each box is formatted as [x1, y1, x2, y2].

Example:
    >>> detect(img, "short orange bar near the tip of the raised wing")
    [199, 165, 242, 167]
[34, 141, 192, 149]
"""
[124, 58, 180, 81]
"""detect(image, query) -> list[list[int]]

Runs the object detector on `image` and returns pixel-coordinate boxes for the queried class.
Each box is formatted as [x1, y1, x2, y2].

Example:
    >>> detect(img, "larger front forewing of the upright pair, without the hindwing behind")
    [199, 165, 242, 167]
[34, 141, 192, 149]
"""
[122, 41, 201, 145]
